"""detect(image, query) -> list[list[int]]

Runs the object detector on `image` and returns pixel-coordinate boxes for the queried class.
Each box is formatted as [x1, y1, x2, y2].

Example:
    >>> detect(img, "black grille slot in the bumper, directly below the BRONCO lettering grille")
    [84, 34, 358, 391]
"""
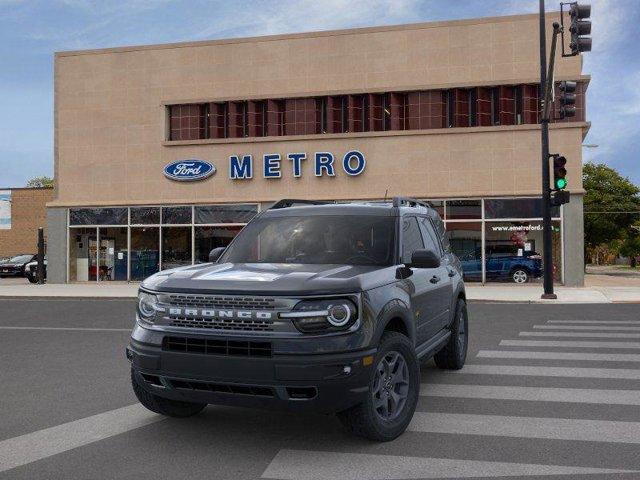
[162, 337, 271, 357]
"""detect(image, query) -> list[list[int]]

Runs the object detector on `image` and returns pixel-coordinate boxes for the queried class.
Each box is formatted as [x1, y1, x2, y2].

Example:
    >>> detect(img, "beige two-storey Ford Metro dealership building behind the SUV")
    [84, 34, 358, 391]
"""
[47, 14, 589, 286]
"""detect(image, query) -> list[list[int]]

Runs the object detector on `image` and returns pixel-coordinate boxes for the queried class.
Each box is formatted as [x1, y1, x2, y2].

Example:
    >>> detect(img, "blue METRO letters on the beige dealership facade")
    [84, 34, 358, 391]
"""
[229, 150, 367, 180]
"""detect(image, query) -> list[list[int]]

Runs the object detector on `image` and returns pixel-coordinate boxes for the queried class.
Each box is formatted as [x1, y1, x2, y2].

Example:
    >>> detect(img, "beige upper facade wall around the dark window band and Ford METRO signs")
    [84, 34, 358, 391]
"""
[51, 15, 585, 206]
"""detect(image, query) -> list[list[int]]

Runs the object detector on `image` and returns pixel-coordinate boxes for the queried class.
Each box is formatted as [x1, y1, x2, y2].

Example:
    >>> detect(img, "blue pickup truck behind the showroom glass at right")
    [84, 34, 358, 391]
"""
[459, 245, 542, 283]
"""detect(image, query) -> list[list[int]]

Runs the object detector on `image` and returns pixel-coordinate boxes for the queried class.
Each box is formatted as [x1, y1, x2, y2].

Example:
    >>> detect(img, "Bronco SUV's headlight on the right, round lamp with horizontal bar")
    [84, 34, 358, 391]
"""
[280, 298, 358, 333]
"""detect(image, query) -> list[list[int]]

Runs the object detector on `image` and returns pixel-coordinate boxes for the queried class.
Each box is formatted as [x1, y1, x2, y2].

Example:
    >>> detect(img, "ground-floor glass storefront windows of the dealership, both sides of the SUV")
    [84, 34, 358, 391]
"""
[68, 198, 563, 284]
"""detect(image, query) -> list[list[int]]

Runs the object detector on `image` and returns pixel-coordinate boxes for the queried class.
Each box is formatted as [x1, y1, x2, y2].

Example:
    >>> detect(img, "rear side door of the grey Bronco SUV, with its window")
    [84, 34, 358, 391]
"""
[418, 216, 455, 330]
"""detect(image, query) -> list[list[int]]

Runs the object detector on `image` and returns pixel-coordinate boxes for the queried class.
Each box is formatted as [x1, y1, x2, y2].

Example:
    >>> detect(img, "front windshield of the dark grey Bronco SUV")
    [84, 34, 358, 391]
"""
[220, 215, 395, 266]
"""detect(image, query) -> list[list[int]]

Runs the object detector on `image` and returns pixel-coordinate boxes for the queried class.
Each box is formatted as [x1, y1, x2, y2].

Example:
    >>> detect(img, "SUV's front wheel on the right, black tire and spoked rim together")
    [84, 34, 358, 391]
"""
[338, 332, 420, 442]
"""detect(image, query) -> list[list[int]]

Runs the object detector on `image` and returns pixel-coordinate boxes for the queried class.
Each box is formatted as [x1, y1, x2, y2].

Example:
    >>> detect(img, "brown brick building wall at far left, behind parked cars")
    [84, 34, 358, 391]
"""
[0, 188, 53, 257]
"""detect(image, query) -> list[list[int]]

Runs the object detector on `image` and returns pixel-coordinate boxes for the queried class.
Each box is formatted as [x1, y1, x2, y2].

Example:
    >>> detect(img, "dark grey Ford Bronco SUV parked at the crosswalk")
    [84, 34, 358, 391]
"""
[126, 197, 468, 441]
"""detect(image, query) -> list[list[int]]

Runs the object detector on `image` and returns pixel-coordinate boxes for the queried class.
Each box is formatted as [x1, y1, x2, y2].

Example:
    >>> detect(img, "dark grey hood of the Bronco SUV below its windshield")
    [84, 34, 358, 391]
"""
[142, 263, 395, 295]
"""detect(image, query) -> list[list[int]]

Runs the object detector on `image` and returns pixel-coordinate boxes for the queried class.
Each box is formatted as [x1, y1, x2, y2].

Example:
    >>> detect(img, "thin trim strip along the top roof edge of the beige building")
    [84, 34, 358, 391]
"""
[54, 12, 560, 58]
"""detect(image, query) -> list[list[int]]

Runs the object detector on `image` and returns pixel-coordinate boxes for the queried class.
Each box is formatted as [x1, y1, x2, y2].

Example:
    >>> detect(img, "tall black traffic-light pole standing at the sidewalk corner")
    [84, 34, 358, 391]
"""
[540, 0, 557, 299]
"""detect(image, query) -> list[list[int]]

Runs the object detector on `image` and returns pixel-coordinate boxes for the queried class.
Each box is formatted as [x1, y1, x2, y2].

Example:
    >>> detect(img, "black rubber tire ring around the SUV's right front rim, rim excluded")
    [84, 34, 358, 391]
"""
[365, 333, 420, 440]
